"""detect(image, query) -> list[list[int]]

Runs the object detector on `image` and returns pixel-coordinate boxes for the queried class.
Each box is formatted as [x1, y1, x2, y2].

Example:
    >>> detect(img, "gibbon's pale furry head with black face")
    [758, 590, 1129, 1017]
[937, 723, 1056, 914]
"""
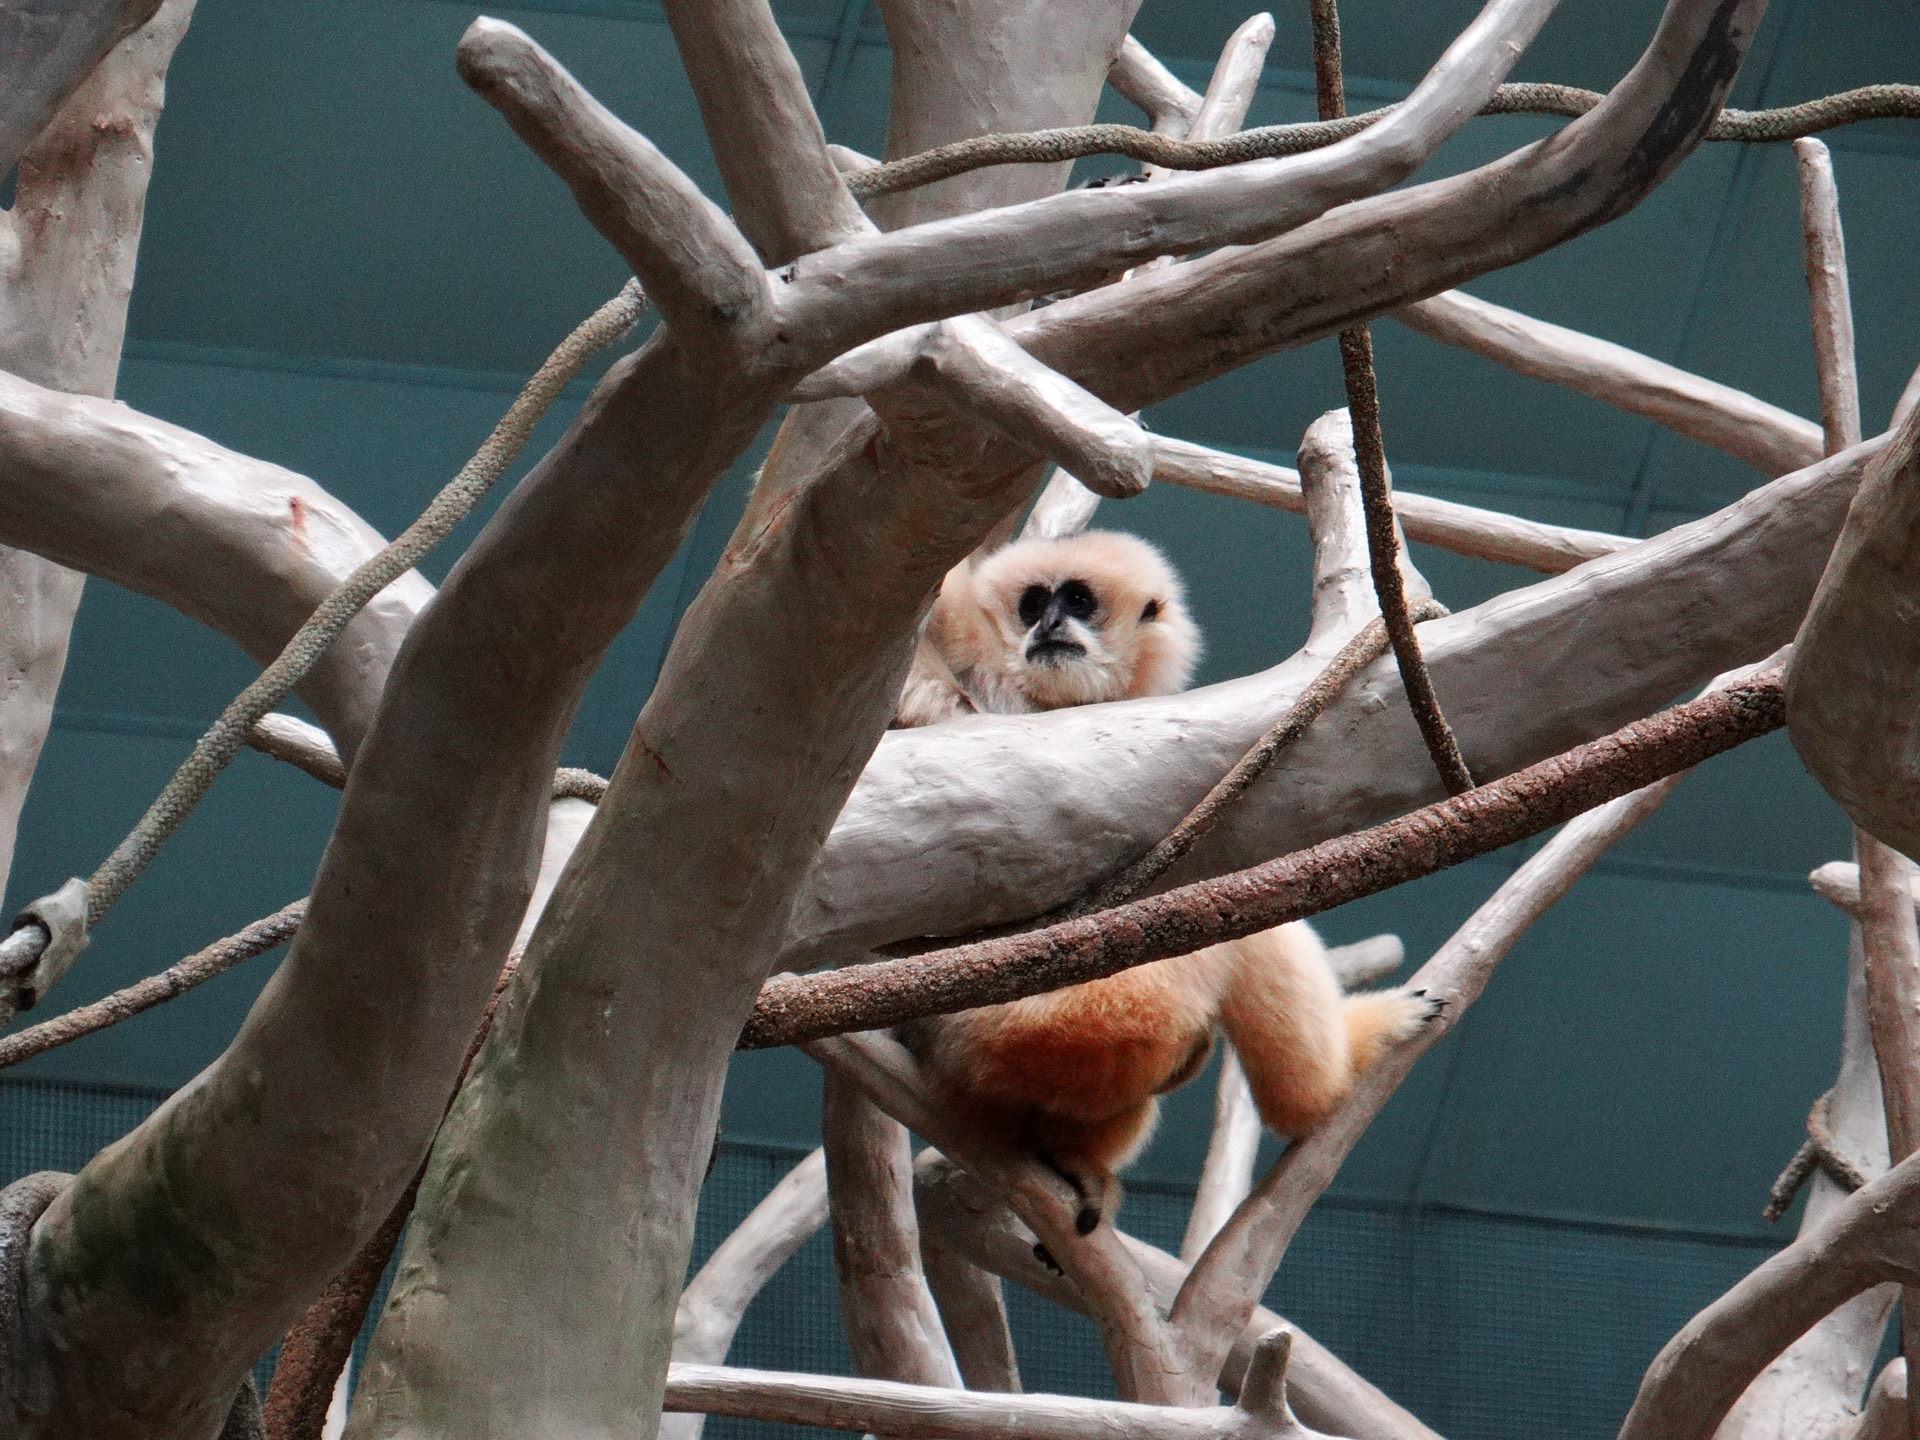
[973, 530, 1200, 710]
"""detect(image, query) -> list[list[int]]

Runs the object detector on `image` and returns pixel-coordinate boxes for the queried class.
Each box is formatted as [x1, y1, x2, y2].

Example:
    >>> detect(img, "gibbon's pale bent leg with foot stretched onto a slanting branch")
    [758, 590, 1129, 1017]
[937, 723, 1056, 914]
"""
[1217, 922, 1434, 1137]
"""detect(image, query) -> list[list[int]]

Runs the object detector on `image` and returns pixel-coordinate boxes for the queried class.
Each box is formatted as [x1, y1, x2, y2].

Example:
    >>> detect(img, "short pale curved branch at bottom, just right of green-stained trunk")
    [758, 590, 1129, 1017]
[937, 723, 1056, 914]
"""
[660, 1150, 828, 1440]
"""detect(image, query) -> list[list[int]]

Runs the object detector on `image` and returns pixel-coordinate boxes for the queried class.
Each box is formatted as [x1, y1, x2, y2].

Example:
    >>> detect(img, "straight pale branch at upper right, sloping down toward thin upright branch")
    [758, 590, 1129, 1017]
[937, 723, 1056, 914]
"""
[1394, 289, 1812, 476]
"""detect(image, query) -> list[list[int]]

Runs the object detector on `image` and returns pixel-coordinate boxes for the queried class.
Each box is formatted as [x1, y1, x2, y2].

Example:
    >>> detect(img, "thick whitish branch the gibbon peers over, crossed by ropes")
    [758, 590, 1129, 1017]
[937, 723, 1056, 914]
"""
[783, 433, 1884, 970]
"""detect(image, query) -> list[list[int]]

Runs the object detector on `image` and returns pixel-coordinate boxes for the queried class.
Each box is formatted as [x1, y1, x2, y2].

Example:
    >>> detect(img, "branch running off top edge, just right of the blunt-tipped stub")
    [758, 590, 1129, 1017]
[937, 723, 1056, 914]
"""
[666, 0, 874, 265]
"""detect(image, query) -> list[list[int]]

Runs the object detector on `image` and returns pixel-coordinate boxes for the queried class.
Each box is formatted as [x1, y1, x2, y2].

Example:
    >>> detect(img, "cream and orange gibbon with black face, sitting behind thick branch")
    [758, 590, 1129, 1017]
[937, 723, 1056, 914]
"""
[895, 532, 1438, 1235]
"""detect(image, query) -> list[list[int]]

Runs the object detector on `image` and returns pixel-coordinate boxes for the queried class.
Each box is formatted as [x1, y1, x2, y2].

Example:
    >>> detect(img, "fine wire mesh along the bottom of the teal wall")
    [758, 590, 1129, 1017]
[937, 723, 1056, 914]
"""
[0, 1079, 1774, 1440]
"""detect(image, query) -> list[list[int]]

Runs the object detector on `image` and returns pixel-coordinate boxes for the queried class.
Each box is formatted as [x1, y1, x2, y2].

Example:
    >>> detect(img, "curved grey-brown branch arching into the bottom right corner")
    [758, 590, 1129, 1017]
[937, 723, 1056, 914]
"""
[1620, 1156, 1920, 1440]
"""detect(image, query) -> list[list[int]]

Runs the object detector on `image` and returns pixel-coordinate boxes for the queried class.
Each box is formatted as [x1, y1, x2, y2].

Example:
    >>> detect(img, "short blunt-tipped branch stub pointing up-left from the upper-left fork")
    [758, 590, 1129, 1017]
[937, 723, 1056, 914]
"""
[459, 15, 770, 346]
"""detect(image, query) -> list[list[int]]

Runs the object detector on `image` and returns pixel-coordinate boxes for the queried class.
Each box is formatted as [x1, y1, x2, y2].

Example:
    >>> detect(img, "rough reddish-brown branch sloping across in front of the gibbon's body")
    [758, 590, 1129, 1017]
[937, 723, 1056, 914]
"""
[739, 672, 1786, 1050]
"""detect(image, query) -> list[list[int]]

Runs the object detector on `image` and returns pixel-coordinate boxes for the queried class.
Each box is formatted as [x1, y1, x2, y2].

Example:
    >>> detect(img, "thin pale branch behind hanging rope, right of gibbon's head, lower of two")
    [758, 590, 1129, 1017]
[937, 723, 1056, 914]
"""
[1154, 436, 1640, 574]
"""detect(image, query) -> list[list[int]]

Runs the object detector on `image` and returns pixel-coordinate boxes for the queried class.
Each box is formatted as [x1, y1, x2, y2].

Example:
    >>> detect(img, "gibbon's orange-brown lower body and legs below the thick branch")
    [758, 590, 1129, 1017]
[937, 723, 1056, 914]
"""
[904, 924, 1430, 1210]
